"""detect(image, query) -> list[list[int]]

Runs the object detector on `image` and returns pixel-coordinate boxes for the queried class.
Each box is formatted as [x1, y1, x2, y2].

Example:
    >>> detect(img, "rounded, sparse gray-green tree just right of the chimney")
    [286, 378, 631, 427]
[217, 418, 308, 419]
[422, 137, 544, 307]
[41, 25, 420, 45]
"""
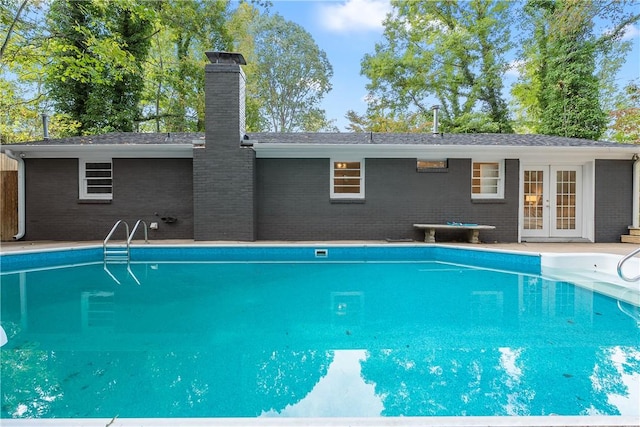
[249, 15, 335, 132]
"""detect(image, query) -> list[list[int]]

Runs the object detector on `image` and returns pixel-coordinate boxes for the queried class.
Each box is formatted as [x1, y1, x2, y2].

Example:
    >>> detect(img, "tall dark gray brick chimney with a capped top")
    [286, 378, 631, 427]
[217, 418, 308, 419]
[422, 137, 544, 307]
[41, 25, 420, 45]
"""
[193, 52, 256, 241]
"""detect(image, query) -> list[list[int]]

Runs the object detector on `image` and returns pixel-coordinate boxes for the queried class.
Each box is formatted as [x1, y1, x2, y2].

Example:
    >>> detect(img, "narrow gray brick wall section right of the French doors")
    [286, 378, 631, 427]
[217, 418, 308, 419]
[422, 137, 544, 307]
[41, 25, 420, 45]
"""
[595, 160, 633, 243]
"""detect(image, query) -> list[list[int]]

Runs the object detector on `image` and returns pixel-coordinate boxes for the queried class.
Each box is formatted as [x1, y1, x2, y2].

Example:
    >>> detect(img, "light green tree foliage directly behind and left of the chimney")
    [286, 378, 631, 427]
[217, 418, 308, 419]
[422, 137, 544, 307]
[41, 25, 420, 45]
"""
[141, 0, 232, 132]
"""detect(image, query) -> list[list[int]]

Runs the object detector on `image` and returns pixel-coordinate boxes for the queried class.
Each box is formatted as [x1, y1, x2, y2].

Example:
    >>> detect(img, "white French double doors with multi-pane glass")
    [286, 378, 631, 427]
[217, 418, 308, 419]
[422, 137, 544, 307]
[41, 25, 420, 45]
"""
[522, 165, 582, 238]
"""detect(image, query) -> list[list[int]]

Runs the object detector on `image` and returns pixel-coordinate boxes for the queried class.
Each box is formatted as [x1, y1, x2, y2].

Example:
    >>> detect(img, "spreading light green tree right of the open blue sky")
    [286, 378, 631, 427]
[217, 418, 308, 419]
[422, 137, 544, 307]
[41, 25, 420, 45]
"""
[362, 0, 512, 132]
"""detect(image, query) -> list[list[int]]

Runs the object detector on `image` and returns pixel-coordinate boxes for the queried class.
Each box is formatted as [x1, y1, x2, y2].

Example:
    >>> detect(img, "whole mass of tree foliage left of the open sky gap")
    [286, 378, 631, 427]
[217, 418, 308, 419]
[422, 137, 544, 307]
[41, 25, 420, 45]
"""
[0, 0, 335, 137]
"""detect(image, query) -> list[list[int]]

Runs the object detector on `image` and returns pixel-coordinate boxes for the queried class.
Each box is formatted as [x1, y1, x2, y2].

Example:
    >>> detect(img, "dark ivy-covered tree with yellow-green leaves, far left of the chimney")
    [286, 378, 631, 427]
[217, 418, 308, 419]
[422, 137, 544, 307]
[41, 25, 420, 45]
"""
[47, 0, 153, 134]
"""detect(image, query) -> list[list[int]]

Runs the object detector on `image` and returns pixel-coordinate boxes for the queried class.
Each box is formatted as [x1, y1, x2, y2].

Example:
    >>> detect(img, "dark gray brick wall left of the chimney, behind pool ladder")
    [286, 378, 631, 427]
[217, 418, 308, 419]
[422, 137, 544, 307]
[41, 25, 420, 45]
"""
[25, 159, 193, 241]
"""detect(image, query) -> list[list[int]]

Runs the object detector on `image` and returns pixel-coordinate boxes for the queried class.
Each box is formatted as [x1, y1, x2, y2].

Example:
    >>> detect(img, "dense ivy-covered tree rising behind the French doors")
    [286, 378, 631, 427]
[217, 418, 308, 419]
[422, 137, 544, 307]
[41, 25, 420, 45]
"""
[512, 0, 640, 139]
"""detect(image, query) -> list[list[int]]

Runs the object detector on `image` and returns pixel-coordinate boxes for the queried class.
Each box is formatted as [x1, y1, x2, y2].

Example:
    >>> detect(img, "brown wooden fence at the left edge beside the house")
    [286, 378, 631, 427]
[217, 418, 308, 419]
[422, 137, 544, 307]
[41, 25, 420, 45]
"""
[0, 154, 18, 241]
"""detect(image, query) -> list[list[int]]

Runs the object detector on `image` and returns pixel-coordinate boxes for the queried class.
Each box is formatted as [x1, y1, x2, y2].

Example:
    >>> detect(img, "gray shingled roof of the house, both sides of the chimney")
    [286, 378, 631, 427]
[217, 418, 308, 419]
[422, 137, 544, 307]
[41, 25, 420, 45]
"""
[2, 132, 629, 148]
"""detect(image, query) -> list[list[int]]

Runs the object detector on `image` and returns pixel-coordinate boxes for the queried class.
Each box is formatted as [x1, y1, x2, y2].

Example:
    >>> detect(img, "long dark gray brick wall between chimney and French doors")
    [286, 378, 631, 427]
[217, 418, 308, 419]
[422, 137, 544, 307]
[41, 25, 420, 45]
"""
[256, 159, 518, 242]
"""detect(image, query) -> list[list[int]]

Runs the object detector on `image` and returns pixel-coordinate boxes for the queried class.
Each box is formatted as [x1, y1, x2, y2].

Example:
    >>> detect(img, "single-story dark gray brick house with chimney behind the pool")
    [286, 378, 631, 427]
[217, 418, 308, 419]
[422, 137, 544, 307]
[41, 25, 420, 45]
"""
[2, 52, 640, 242]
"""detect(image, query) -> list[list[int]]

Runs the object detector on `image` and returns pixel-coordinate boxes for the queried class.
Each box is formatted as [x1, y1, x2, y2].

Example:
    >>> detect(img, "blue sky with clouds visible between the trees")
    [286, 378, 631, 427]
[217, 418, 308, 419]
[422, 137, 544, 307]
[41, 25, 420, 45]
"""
[264, 0, 640, 132]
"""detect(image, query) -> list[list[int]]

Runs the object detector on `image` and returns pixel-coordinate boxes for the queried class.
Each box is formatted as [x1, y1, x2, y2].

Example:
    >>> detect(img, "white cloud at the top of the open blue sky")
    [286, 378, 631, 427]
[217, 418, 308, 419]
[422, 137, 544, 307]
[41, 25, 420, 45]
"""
[320, 0, 391, 32]
